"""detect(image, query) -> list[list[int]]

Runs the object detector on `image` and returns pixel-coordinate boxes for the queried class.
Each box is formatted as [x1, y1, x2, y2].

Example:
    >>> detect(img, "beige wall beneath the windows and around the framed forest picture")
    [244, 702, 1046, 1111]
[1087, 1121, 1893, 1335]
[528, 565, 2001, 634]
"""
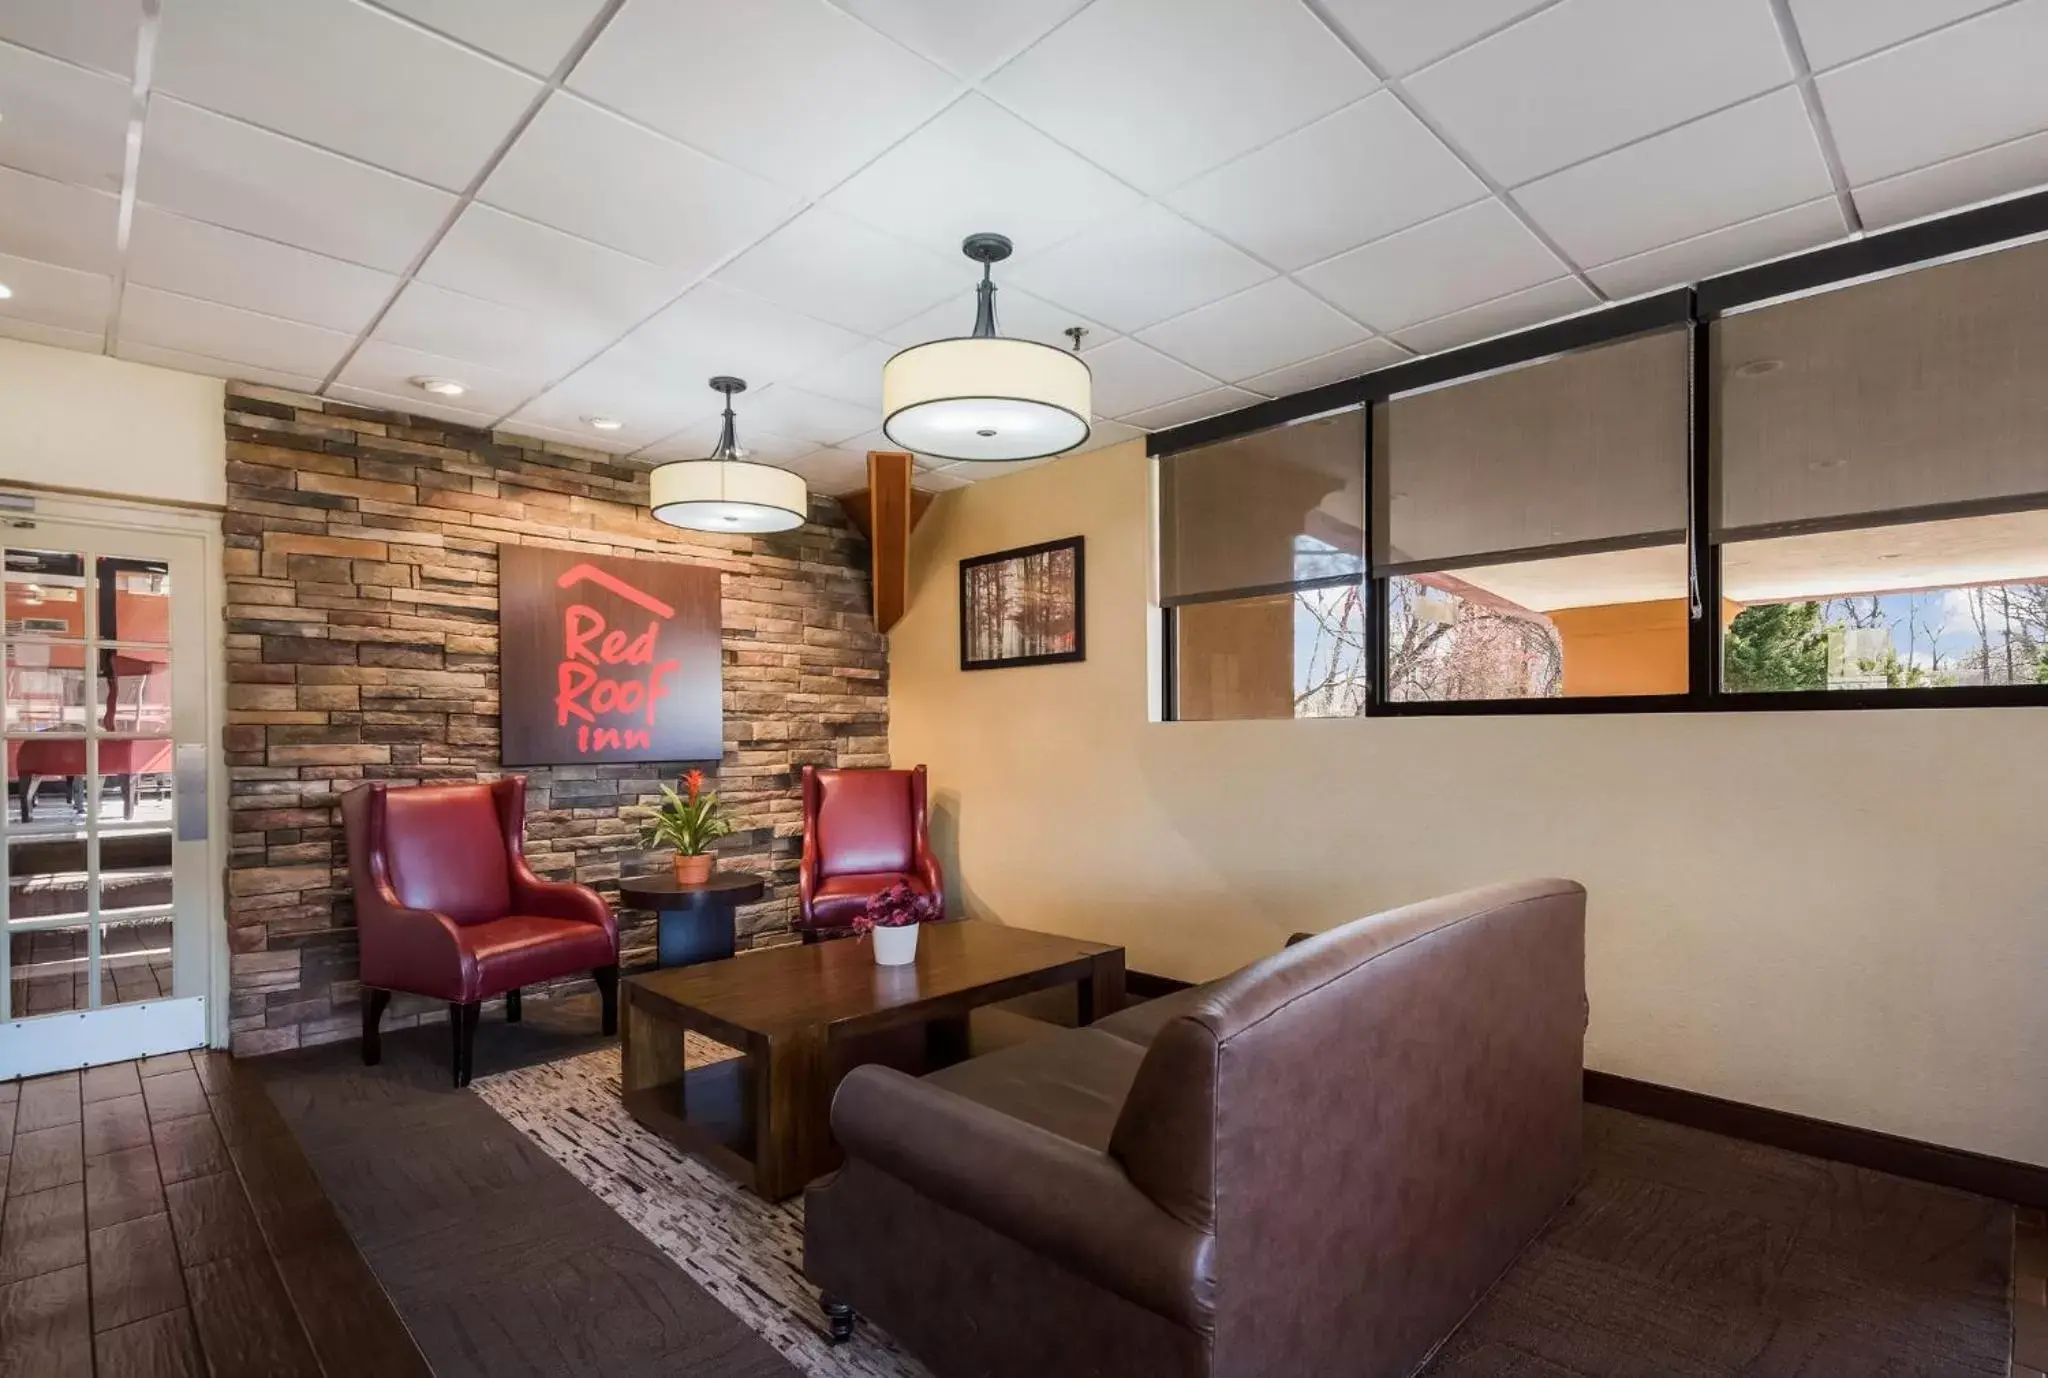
[889, 444, 2048, 1163]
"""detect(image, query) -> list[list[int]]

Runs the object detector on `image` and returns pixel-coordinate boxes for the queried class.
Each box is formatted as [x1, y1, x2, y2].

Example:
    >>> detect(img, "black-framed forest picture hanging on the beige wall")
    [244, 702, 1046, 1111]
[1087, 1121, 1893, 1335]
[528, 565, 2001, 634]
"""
[961, 536, 1087, 670]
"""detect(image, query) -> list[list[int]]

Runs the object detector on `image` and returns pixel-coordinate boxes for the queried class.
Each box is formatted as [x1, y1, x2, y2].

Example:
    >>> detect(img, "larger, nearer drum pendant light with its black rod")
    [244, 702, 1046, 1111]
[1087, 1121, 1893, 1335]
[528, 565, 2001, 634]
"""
[883, 233, 1090, 463]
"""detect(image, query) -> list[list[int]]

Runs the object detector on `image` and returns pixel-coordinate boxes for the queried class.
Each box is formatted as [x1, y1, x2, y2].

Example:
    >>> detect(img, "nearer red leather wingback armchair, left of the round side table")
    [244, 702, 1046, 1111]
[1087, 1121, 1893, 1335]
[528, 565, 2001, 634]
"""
[342, 776, 618, 1085]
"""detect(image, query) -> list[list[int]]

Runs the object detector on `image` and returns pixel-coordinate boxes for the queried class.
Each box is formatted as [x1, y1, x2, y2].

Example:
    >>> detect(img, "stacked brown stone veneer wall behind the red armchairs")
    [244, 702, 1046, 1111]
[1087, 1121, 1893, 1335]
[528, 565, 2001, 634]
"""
[223, 383, 889, 1054]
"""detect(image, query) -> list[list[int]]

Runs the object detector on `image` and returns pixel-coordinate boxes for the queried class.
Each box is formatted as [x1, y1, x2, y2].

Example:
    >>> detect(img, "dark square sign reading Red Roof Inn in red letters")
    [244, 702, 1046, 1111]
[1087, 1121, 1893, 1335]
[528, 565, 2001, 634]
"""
[498, 545, 725, 766]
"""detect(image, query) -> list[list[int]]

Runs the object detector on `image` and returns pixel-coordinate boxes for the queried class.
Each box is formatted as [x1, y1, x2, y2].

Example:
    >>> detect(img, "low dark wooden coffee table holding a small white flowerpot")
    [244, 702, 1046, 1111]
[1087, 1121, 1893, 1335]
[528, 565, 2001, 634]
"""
[621, 921, 1124, 1200]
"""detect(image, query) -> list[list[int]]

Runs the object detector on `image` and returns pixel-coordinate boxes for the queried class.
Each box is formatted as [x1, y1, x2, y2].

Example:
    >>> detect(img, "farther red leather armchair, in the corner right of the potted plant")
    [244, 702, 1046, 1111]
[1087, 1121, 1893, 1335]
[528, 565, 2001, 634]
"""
[797, 766, 946, 942]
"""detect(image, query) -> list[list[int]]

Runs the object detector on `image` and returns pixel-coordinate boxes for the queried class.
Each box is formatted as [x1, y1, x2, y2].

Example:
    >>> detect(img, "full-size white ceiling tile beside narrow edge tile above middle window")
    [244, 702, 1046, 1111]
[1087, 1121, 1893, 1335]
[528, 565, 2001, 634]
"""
[1294, 199, 1565, 332]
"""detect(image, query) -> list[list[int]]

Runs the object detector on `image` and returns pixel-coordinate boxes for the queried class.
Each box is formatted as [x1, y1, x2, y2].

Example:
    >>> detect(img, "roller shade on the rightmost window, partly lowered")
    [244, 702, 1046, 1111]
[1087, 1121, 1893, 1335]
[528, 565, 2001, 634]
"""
[1710, 233, 2048, 541]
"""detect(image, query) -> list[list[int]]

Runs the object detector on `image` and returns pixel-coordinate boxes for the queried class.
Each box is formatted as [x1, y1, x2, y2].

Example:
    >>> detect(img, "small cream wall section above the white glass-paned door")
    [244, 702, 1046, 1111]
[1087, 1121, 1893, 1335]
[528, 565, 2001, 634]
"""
[0, 340, 227, 508]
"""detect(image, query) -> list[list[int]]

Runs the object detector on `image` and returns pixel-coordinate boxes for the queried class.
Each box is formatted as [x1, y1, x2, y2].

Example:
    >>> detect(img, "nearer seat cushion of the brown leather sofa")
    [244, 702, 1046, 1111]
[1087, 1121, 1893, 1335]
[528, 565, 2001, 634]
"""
[926, 1028, 1145, 1151]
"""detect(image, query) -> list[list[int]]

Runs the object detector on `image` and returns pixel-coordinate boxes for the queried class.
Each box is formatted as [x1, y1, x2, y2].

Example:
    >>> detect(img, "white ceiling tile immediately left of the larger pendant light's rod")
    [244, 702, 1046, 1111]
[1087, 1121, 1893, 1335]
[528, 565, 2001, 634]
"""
[717, 207, 962, 336]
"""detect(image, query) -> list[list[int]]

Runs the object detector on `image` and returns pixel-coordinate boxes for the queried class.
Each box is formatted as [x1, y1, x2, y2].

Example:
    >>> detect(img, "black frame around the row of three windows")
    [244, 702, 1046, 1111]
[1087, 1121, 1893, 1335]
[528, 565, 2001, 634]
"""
[1145, 192, 2048, 721]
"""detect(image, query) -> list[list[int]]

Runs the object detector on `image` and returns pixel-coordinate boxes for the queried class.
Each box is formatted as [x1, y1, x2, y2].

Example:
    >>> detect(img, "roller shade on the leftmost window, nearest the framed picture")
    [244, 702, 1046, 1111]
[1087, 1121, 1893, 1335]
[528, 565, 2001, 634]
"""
[1159, 412, 1366, 606]
